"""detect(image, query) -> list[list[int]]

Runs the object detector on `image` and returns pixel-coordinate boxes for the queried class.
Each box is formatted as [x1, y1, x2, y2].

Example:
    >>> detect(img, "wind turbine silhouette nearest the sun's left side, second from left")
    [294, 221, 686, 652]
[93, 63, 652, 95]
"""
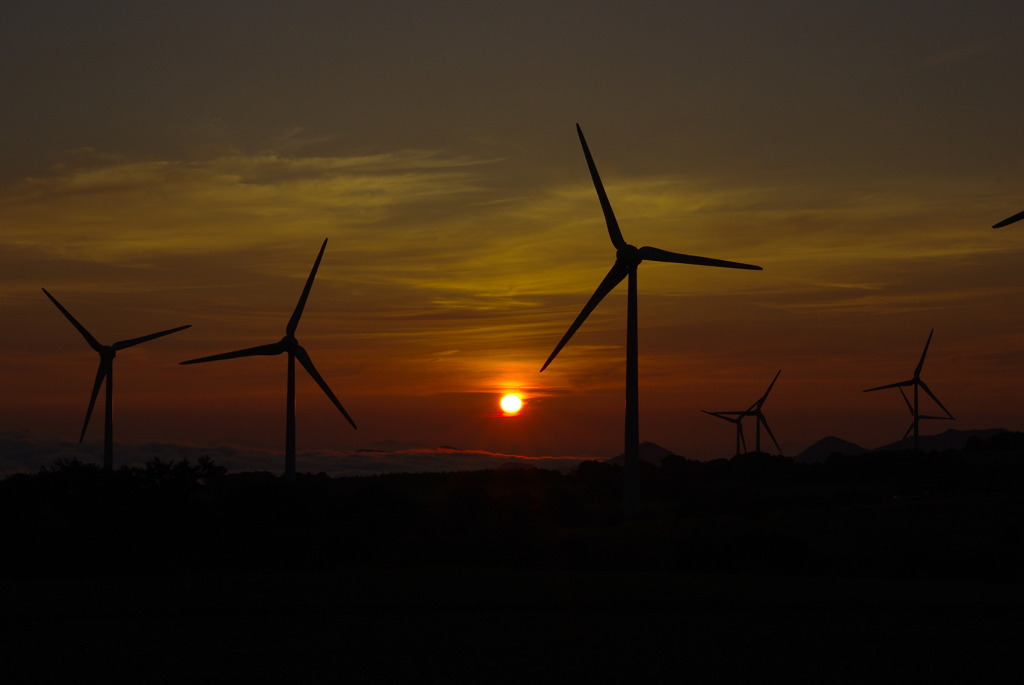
[180, 239, 355, 477]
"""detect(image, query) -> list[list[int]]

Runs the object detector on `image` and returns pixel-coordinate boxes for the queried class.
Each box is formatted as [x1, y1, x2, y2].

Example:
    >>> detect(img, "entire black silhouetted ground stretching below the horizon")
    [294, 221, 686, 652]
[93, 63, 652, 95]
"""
[0, 438, 1024, 683]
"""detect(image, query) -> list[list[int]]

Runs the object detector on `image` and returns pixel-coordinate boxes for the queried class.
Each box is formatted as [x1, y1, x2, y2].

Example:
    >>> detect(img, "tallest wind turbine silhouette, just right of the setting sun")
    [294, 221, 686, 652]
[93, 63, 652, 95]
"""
[541, 124, 761, 514]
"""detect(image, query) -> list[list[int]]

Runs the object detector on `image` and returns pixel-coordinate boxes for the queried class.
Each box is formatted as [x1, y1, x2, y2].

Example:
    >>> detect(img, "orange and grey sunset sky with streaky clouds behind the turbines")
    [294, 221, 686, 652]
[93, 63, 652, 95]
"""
[0, 0, 1024, 470]
